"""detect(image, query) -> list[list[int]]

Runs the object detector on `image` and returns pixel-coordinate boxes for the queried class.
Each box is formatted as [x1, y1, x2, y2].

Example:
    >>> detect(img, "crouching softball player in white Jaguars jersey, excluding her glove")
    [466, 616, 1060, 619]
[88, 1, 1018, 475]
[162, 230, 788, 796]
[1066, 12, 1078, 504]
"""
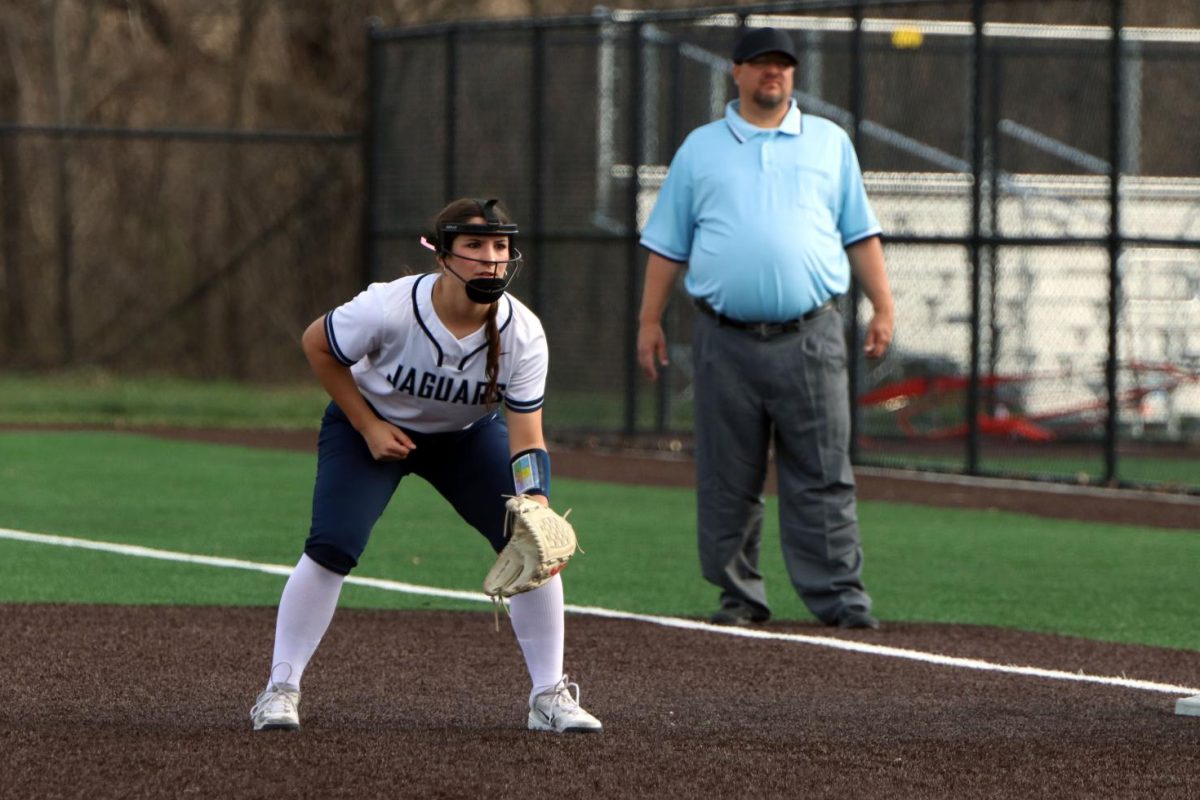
[251, 199, 601, 733]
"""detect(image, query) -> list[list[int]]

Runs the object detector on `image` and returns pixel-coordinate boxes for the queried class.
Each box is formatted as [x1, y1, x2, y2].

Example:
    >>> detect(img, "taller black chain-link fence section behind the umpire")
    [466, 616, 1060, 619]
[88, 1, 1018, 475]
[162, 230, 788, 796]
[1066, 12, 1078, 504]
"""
[365, 0, 1200, 488]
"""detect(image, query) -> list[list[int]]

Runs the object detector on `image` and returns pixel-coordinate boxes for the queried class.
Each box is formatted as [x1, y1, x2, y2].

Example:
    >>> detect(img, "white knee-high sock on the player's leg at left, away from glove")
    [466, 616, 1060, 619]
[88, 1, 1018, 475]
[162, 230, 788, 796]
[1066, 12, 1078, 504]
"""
[268, 555, 346, 688]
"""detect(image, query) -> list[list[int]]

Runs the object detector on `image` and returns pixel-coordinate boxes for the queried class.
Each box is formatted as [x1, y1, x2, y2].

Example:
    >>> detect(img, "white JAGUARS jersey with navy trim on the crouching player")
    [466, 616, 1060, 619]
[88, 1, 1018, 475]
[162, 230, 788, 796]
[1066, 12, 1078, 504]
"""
[325, 272, 550, 433]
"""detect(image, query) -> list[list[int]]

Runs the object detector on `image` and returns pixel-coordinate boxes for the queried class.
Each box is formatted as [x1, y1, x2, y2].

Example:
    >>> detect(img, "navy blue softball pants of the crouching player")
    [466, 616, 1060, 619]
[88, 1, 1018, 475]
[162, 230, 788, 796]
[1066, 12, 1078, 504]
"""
[304, 403, 514, 575]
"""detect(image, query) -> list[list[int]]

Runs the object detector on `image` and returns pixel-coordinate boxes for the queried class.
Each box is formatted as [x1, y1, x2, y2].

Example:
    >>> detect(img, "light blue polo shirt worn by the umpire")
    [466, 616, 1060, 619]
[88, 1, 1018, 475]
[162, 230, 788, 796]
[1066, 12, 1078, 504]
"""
[641, 101, 881, 321]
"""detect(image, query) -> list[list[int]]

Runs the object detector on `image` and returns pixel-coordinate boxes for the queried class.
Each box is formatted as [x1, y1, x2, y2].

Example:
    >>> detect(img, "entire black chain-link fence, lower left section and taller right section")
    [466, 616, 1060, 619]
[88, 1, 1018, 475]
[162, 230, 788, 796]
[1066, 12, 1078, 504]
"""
[0, 0, 1200, 491]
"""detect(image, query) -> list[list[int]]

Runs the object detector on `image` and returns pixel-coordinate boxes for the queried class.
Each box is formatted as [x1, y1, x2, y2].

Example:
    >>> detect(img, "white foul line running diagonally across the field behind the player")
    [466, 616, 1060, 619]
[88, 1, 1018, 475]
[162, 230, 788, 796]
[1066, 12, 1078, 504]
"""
[0, 528, 1200, 694]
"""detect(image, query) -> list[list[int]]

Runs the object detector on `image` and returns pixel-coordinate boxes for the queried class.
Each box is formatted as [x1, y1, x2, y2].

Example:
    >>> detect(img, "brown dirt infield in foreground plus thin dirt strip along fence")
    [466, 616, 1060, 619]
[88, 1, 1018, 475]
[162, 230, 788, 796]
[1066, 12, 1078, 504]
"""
[0, 432, 1200, 799]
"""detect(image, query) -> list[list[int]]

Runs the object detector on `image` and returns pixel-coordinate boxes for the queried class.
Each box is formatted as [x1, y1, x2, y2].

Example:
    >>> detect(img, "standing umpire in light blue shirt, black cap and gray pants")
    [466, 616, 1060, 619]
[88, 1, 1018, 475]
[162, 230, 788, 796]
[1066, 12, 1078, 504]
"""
[637, 28, 895, 628]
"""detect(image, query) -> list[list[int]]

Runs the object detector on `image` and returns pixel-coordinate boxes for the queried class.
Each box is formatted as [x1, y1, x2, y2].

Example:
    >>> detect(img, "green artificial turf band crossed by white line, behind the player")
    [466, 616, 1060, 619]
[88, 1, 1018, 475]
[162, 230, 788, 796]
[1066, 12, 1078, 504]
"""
[0, 432, 1200, 650]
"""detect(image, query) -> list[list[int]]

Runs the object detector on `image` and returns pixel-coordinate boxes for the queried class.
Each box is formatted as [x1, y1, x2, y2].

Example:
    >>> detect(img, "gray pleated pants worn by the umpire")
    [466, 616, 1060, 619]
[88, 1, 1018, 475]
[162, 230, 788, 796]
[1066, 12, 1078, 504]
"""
[692, 309, 871, 624]
